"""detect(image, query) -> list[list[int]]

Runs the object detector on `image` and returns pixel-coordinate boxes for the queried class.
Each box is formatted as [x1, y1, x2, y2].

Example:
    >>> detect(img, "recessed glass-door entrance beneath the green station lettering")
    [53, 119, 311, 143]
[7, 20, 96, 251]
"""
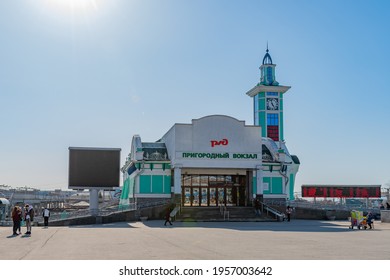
[182, 175, 247, 207]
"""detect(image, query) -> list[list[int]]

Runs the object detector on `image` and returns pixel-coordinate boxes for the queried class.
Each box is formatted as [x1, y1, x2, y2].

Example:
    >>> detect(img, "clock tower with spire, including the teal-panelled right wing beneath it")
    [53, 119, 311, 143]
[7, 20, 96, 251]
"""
[246, 46, 300, 202]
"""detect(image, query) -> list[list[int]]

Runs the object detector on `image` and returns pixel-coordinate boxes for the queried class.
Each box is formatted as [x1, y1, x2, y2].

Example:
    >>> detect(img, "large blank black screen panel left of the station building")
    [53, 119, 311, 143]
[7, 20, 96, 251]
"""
[69, 147, 121, 189]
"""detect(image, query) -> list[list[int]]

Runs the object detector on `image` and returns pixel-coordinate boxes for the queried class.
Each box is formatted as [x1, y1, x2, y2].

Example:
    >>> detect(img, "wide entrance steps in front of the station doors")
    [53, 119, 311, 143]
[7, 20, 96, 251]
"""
[176, 207, 275, 222]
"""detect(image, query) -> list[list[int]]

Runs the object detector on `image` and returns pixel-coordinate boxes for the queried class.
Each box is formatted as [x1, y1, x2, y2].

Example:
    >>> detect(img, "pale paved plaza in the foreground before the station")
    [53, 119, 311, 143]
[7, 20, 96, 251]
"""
[0, 220, 390, 260]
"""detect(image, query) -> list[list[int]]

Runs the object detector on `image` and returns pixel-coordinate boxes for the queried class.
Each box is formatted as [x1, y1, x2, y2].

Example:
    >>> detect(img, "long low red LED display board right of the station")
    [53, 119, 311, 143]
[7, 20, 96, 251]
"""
[302, 185, 381, 198]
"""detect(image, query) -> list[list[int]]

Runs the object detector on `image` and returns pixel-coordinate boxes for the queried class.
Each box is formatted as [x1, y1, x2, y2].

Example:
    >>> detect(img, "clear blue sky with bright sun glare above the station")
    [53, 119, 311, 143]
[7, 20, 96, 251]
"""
[0, 0, 390, 191]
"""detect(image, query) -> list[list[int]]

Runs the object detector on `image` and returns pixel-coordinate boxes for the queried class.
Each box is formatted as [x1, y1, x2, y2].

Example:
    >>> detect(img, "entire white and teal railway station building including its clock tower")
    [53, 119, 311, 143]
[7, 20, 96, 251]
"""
[120, 49, 300, 207]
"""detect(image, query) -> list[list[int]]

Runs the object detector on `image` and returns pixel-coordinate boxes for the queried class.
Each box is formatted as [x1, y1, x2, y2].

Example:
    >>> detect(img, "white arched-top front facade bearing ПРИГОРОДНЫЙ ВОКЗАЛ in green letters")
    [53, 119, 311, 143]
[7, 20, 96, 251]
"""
[161, 115, 263, 199]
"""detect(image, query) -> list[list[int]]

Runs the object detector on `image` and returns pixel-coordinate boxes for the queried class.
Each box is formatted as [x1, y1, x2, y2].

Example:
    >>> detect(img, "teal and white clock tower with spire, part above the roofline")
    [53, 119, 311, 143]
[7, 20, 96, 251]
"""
[246, 47, 290, 142]
